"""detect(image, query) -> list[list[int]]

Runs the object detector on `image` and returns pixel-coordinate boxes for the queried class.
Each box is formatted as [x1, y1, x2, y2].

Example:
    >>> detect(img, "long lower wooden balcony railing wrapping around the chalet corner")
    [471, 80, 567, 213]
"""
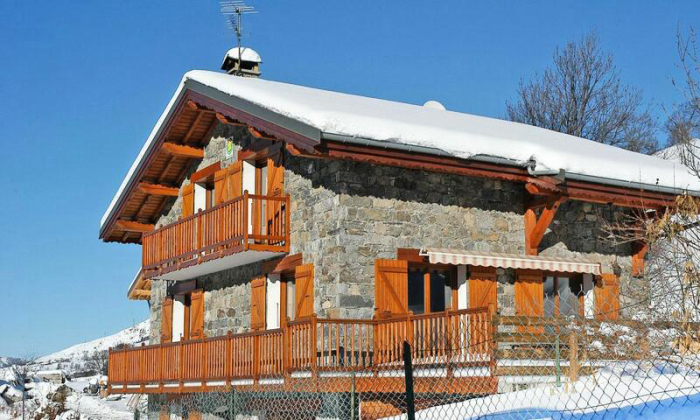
[109, 308, 496, 394]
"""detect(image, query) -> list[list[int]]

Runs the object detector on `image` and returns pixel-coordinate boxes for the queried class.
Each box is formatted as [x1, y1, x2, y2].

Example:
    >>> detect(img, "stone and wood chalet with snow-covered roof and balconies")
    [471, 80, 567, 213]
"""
[99, 49, 700, 416]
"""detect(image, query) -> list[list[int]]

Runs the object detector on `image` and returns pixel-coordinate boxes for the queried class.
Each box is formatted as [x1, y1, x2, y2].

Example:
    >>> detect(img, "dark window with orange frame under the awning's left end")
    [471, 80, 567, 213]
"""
[408, 266, 456, 315]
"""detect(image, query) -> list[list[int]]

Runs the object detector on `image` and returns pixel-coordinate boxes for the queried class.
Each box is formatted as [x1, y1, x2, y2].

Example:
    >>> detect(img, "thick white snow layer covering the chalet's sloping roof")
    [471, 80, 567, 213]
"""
[102, 70, 700, 231]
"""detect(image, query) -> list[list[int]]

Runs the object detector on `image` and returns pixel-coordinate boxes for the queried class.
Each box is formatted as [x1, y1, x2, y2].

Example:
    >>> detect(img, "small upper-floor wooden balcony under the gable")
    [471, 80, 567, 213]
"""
[143, 192, 289, 280]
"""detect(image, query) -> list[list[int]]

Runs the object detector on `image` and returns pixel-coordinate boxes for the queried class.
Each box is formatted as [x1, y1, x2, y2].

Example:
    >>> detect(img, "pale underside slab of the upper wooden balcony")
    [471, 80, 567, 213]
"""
[152, 250, 286, 281]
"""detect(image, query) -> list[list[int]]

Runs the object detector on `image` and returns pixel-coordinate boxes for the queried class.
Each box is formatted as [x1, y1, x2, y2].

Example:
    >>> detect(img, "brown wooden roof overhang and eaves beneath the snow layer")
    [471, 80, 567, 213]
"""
[99, 72, 700, 243]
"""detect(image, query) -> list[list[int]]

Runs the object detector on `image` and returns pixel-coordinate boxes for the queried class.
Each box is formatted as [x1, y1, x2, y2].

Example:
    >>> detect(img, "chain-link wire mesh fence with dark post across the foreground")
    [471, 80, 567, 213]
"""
[119, 302, 700, 420]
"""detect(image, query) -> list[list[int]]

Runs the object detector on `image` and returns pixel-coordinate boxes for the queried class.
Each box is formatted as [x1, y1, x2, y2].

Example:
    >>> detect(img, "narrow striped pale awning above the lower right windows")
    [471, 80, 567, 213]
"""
[421, 248, 601, 276]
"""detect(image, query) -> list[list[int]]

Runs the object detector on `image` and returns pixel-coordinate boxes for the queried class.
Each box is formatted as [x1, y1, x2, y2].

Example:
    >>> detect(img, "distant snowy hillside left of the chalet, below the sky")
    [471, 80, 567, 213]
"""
[35, 320, 150, 374]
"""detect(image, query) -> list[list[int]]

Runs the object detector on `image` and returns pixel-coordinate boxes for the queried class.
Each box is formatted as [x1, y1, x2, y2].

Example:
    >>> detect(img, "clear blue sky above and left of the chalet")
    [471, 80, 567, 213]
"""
[0, 0, 700, 356]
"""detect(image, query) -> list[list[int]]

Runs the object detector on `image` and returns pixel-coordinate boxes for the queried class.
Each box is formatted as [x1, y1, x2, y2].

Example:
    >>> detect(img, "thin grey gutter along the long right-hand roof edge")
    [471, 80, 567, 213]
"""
[321, 132, 700, 197]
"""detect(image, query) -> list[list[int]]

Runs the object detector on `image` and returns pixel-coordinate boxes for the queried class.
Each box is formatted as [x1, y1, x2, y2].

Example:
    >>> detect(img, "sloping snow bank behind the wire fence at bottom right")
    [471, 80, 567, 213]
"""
[386, 363, 700, 420]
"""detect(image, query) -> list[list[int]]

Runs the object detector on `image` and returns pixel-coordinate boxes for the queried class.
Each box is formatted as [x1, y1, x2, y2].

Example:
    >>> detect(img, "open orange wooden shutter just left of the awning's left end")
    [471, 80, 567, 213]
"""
[374, 259, 408, 315]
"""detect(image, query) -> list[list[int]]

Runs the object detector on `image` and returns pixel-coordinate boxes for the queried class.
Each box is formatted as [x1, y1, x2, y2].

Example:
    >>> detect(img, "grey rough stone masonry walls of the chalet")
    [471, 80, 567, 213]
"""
[151, 126, 631, 341]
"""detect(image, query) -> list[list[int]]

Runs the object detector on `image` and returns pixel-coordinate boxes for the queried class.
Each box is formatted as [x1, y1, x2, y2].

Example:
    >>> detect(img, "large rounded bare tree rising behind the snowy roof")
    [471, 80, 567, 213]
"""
[506, 32, 658, 153]
